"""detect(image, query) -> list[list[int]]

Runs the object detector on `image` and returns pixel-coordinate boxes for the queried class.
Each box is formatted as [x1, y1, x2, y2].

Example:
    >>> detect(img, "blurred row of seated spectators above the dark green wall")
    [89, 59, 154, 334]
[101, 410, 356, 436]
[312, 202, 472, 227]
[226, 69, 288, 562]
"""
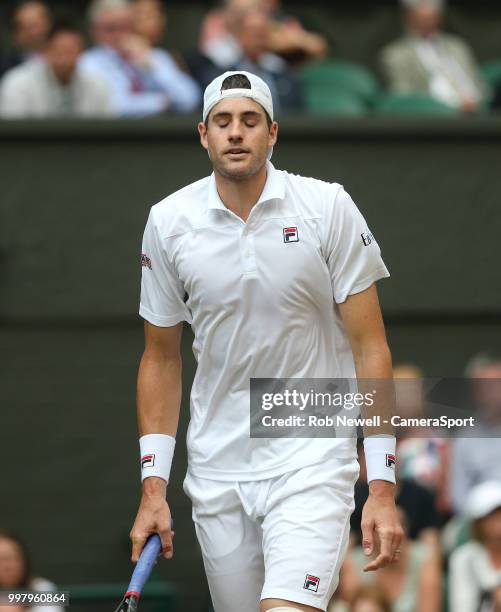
[0, 0, 501, 118]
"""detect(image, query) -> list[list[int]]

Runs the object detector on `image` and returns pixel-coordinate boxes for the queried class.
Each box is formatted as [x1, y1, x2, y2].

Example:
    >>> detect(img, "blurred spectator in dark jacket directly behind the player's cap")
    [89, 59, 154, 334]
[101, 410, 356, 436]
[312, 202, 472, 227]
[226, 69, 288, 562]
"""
[187, 0, 303, 111]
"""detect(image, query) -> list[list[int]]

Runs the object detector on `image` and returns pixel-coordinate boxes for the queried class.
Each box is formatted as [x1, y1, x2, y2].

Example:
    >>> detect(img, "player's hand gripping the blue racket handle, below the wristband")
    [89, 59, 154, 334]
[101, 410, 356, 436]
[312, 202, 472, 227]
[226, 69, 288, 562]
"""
[130, 476, 174, 563]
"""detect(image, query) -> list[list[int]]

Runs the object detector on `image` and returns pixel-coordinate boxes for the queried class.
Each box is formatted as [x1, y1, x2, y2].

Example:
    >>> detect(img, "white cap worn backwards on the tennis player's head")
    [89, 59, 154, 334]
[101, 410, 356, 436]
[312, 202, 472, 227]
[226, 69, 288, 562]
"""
[203, 70, 273, 121]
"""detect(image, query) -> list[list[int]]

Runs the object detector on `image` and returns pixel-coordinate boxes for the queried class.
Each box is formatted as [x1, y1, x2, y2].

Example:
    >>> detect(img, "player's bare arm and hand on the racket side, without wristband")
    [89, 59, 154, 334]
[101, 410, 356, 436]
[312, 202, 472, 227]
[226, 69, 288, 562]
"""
[130, 322, 183, 562]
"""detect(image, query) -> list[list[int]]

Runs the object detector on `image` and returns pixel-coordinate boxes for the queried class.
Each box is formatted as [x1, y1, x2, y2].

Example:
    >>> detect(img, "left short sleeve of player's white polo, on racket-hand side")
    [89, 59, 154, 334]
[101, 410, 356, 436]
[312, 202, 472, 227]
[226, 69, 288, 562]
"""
[139, 210, 191, 327]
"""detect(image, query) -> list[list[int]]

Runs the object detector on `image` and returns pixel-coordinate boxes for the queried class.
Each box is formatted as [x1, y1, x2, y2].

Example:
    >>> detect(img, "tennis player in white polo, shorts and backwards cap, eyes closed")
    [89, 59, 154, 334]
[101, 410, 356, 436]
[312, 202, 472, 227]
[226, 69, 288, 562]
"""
[131, 72, 403, 612]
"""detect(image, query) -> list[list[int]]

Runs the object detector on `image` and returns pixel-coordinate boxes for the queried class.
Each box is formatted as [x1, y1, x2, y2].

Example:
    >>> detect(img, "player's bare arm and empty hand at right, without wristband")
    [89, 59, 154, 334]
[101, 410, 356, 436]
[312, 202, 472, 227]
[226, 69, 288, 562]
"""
[339, 284, 404, 571]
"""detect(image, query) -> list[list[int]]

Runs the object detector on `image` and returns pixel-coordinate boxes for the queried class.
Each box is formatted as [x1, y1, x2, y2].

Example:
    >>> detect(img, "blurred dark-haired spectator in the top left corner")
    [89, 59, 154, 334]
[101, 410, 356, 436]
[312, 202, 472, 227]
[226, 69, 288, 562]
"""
[0, 0, 52, 76]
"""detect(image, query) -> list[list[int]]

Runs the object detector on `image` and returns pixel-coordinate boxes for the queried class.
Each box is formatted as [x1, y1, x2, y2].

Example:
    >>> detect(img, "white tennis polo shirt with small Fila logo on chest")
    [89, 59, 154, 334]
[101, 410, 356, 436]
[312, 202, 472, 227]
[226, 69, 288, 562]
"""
[139, 162, 389, 480]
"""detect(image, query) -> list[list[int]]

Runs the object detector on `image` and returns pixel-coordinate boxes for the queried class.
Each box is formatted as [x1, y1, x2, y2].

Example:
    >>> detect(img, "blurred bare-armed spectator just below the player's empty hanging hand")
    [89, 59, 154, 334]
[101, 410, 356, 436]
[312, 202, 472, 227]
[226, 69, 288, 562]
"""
[339, 508, 440, 612]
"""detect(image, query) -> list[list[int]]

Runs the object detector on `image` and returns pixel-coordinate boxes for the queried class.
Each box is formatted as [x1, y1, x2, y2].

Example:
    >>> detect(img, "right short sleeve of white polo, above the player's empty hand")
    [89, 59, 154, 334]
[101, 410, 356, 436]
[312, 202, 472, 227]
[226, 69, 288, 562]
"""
[323, 186, 389, 304]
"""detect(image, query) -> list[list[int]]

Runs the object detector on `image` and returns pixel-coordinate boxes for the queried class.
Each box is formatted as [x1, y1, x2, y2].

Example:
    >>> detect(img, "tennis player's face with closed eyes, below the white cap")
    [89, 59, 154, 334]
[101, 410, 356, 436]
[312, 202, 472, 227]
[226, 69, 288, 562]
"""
[198, 98, 278, 181]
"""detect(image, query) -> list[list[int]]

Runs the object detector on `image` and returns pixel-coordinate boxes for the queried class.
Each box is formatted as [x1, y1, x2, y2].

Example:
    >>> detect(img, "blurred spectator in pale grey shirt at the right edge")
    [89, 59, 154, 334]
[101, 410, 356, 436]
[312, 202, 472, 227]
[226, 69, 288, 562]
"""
[449, 355, 501, 513]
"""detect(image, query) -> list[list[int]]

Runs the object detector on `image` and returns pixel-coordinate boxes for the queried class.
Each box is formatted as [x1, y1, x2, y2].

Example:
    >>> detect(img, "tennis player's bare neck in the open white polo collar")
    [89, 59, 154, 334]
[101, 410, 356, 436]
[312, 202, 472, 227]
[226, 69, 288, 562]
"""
[214, 164, 268, 221]
